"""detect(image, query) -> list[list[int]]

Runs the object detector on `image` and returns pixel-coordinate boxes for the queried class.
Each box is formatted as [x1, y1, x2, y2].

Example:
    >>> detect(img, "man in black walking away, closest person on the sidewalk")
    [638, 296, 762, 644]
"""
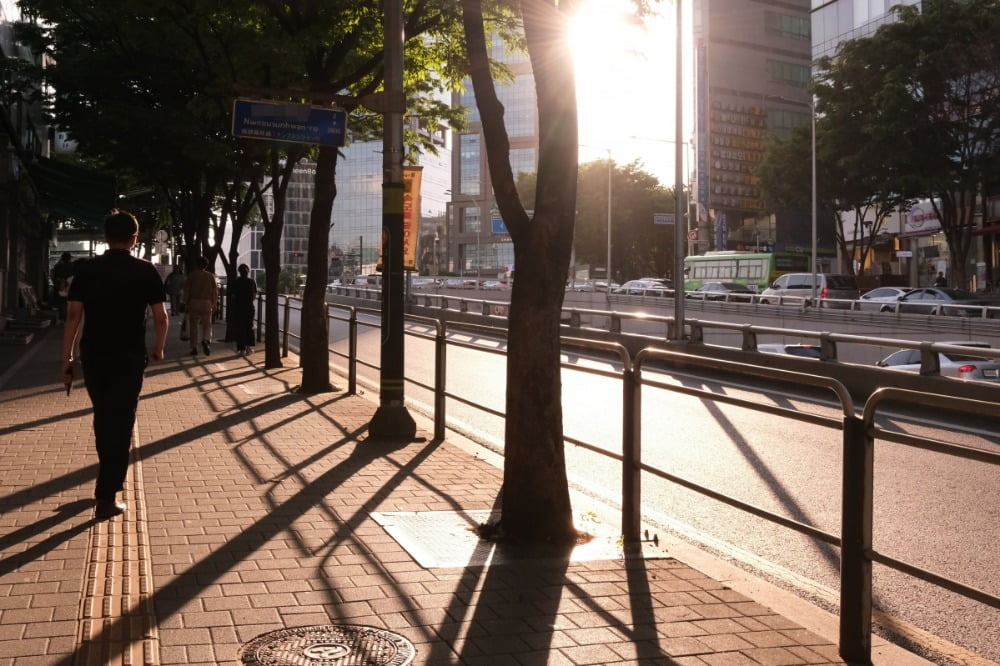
[62, 210, 167, 519]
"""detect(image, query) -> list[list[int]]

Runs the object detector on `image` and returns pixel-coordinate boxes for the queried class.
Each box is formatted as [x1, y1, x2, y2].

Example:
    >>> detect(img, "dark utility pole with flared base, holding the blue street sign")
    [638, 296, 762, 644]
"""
[368, 0, 417, 439]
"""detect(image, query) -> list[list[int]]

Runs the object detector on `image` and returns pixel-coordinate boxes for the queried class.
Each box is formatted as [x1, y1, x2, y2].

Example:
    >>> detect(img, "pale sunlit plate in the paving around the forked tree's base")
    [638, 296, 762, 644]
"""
[371, 510, 648, 569]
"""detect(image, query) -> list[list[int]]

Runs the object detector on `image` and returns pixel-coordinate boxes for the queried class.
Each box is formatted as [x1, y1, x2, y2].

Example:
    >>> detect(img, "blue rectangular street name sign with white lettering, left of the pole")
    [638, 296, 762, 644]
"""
[233, 99, 347, 147]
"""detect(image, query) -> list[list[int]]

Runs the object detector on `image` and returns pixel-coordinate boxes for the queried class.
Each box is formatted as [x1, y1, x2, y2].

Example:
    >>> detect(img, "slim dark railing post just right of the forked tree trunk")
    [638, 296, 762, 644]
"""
[622, 356, 642, 548]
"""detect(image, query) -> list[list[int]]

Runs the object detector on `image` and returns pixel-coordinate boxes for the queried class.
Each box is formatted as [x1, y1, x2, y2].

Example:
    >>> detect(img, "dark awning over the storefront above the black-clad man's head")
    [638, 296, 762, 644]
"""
[28, 157, 118, 229]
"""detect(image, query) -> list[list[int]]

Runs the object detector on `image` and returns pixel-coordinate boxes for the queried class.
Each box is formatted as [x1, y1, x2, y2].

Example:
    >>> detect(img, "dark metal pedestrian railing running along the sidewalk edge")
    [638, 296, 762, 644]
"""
[262, 299, 1000, 663]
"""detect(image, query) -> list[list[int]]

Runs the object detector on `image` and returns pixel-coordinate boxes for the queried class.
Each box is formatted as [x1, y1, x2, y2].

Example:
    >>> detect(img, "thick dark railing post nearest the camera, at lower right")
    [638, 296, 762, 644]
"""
[840, 416, 875, 664]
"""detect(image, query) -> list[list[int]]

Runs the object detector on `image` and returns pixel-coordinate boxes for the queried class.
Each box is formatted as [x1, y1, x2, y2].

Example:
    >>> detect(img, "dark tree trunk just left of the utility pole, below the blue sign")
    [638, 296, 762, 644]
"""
[299, 146, 337, 393]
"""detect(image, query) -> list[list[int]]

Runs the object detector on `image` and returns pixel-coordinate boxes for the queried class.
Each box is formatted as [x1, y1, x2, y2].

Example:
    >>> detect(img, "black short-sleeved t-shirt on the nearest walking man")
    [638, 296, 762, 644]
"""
[69, 250, 167, 359]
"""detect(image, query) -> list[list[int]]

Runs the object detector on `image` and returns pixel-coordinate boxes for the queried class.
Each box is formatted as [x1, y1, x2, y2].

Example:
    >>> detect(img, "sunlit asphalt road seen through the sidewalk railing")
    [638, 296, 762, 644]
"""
[293, 304, 1000, 663]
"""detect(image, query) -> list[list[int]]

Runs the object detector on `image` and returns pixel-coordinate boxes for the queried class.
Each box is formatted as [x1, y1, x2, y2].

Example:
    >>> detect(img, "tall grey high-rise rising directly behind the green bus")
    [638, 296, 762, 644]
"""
[692, 0, 834, 258]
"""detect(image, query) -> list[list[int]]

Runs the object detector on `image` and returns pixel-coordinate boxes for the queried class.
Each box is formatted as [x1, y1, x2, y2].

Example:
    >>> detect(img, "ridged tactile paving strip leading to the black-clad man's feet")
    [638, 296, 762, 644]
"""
[74, 447, 160, 666]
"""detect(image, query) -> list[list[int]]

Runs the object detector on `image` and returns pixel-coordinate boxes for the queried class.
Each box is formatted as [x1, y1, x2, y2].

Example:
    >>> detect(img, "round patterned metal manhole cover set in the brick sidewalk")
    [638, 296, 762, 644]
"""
[240, 624, 416, 666]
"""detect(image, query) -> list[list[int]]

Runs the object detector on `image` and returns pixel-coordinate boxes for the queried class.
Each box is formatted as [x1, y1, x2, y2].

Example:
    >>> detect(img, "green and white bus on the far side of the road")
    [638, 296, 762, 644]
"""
[684, 250, 811, 292]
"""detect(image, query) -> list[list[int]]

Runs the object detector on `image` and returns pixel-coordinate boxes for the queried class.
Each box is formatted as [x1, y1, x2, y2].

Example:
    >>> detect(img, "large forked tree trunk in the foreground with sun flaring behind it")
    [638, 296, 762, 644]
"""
[463, 0, 577, 544]
